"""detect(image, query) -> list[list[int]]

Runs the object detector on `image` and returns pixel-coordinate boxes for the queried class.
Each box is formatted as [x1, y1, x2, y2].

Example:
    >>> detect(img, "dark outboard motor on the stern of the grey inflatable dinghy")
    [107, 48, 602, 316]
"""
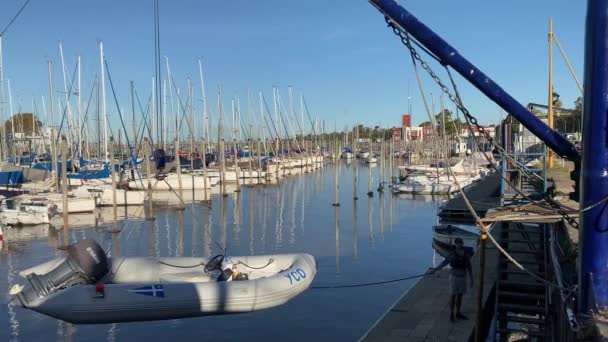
[11, 239, 109, 306]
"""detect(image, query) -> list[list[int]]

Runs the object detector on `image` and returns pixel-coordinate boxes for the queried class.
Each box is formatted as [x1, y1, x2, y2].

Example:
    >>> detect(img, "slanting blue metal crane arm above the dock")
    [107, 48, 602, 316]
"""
[369, 0, 580, 162]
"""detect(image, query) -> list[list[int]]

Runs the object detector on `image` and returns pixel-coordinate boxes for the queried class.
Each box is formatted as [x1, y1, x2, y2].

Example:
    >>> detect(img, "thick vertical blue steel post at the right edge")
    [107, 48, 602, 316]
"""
[578, 0, 608, 313]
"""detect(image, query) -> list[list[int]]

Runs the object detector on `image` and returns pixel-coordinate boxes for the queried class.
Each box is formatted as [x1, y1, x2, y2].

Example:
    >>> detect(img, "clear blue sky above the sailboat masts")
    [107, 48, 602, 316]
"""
[0, 0, 586, 136]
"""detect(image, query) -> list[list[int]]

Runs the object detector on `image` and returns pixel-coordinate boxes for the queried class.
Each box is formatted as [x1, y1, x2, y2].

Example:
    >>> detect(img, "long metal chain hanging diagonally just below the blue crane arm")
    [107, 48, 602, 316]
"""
[384, 17, 579, 229]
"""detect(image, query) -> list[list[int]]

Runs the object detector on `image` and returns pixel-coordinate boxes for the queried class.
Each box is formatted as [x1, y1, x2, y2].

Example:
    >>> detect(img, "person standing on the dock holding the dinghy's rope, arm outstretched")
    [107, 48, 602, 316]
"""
[428, 238, 473, 322]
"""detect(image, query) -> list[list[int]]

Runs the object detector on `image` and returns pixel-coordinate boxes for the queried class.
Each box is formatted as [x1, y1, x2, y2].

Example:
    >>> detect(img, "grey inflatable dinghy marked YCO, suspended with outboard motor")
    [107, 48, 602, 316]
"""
[10, 239, 317, 323]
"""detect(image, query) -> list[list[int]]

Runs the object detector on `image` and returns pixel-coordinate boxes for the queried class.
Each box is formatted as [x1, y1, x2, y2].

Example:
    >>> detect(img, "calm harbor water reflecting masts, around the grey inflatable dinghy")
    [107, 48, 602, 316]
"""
[0, 162, 452, 341]
